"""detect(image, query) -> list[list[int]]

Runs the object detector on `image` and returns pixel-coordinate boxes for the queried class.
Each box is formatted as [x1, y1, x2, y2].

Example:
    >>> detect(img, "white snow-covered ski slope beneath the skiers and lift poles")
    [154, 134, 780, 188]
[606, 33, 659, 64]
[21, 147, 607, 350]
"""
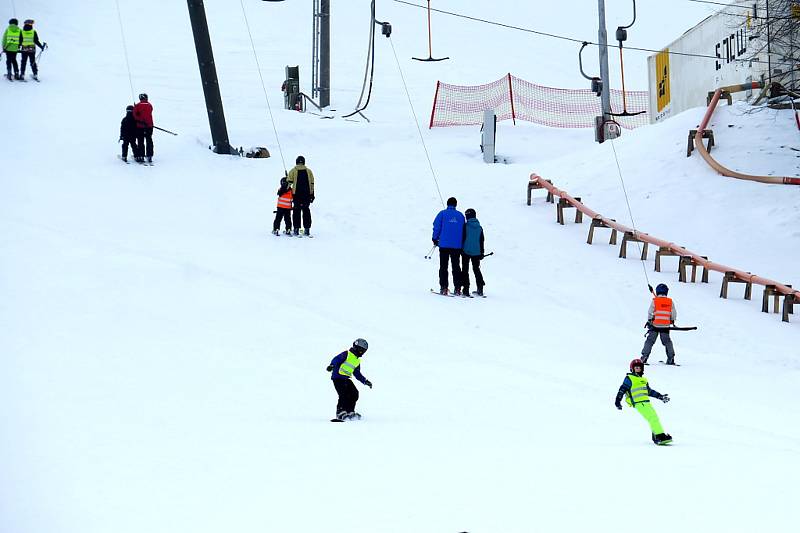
[0, 0, 800, 533]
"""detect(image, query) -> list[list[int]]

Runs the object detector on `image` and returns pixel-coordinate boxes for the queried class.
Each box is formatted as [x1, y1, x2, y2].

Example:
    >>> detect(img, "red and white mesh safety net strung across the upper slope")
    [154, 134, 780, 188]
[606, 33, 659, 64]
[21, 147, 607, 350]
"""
[429, 74, 650, 129]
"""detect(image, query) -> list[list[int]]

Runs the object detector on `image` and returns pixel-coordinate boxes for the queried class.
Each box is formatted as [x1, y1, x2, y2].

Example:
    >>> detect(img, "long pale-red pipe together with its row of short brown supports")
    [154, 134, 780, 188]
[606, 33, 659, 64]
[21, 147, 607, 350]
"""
[528, 174, 800, 322]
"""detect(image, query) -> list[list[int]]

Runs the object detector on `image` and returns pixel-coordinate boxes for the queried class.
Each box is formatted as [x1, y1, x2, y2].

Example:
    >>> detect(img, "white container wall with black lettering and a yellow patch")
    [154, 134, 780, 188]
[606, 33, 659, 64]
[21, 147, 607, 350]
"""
[647, 0, 767, 122]
